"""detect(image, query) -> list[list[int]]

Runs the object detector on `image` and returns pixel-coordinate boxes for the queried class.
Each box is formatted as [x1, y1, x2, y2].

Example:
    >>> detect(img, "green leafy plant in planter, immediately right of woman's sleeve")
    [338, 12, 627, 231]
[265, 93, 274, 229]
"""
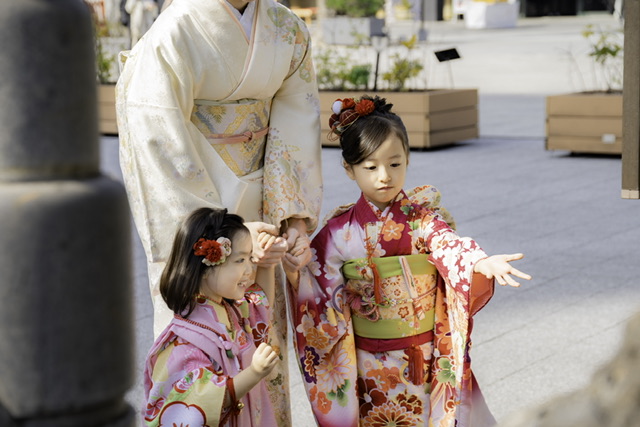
[314, 49, 371, 90]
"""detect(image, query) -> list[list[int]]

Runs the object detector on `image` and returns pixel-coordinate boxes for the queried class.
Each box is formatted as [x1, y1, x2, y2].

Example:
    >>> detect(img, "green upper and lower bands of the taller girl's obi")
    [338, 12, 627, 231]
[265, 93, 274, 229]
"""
[342, 254, 437, 339]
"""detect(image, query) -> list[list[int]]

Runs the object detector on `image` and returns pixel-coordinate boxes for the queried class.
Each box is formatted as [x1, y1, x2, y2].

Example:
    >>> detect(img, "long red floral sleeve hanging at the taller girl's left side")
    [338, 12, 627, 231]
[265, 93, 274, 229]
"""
[291, 228, 358, 426]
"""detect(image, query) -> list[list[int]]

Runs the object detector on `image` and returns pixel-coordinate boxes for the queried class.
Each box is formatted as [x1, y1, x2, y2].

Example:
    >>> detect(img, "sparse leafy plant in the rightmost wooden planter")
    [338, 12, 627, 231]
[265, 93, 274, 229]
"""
[582, 24, 624, 92]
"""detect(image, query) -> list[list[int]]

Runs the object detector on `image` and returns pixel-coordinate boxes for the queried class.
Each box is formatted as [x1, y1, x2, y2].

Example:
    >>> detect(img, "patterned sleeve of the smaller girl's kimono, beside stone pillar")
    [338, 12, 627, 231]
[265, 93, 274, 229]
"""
[143, 338, 227, 427]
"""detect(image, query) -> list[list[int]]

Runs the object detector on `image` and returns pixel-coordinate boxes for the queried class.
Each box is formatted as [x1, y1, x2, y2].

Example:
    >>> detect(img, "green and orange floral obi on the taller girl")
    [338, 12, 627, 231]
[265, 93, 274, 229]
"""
[342, 254, 437, 351]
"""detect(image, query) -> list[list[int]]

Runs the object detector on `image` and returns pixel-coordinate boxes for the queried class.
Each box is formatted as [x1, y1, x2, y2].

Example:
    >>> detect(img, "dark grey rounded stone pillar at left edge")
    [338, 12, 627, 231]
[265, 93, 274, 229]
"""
[0, 0, 135, 427]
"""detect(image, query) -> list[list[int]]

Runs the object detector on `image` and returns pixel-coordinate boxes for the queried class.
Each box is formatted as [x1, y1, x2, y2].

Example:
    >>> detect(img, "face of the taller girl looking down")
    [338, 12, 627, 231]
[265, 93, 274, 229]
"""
[346, 133, 409, 210]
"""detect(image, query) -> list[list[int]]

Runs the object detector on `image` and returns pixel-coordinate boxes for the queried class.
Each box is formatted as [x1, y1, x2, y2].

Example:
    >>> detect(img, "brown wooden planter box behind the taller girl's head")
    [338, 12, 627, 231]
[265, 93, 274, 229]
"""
[320, 89, 478, 148]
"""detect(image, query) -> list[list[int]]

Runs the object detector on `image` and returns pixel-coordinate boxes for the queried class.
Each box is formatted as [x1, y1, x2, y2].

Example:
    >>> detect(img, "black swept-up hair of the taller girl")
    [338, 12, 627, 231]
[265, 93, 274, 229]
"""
[340, 95, 409, 165]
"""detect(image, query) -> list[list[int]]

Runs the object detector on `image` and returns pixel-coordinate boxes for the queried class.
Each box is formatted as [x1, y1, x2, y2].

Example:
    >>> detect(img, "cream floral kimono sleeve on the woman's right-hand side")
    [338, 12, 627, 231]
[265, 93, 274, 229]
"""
[264, 12, 322, 231]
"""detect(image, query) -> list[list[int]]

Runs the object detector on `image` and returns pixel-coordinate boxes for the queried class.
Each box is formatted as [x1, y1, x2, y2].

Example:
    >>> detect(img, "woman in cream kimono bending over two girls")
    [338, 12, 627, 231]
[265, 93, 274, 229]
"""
[116, 0, 322, 425]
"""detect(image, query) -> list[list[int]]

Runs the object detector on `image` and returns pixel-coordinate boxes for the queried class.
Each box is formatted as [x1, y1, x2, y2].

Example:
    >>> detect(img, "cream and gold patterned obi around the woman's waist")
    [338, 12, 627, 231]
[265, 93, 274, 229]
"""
[191, 98, 271, 177]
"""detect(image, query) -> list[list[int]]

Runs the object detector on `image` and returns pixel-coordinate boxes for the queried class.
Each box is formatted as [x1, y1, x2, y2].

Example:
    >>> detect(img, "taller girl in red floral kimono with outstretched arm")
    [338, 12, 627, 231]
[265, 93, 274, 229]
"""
[285, 97, 530, 427]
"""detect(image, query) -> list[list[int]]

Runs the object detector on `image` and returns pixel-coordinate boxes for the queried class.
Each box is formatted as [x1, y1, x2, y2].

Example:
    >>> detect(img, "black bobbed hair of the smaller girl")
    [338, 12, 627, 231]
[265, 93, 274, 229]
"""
[160, 208, 249, 317]
